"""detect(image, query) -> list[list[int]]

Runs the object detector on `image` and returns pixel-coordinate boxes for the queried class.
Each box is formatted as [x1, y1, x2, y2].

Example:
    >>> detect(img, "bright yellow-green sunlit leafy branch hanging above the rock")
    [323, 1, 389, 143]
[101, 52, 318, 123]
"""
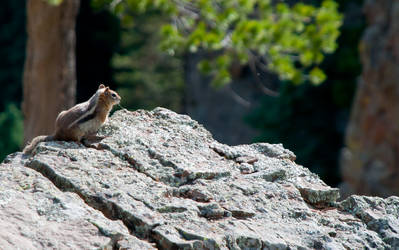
[93, 0, 342, 86]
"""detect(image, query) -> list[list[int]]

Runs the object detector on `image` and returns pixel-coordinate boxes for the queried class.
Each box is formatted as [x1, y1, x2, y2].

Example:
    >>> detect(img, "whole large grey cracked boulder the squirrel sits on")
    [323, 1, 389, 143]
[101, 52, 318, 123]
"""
[0, 108, 399, 249]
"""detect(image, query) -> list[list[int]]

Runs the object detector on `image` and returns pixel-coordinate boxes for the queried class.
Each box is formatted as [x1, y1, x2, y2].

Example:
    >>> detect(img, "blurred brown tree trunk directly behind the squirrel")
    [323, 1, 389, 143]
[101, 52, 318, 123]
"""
[22, 0, 79, 143]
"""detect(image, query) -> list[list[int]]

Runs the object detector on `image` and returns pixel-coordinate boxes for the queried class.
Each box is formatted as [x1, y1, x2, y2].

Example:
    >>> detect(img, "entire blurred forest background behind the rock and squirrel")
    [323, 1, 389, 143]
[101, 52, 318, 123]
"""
[0, 0, 399, 196]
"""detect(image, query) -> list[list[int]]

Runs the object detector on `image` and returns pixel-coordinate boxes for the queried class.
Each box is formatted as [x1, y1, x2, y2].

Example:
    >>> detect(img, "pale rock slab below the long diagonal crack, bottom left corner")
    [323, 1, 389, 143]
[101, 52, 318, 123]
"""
[0, 154, 153, 249]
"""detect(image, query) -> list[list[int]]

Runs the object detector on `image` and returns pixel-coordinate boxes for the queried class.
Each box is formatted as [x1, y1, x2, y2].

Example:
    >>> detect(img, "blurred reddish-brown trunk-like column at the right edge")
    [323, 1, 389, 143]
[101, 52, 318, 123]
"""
[341, 0, 399, 197]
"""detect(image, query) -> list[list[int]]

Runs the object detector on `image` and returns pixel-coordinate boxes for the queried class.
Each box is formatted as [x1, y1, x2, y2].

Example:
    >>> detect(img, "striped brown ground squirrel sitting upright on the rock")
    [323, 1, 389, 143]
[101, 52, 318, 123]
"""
[23, 84, 121, 154]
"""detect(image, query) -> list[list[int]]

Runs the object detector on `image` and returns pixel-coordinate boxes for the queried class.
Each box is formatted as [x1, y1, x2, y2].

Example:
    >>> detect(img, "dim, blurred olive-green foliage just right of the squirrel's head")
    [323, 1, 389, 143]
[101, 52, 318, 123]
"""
[111, 11, 184, 111]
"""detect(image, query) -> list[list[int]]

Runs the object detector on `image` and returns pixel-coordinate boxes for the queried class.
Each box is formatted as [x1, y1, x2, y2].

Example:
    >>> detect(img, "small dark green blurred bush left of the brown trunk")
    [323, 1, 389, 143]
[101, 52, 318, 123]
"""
[0, 104, 23, 161]
